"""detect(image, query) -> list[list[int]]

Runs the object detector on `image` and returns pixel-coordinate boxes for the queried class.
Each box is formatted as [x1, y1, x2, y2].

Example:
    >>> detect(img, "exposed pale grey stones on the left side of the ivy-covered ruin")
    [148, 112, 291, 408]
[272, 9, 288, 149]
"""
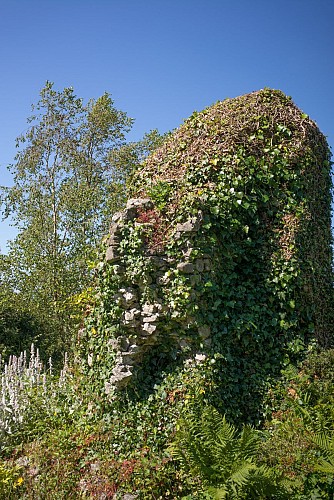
[105, 198, 210, 394]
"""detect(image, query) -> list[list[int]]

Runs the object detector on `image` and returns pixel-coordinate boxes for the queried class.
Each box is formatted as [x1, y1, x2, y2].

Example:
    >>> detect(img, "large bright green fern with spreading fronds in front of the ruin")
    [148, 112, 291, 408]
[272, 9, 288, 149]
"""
[170, 406, 278, 500]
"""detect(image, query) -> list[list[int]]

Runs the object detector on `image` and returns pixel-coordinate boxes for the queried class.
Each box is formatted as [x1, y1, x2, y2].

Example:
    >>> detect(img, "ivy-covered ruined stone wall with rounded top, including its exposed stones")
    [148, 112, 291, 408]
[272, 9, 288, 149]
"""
[79, 89, 334, 422]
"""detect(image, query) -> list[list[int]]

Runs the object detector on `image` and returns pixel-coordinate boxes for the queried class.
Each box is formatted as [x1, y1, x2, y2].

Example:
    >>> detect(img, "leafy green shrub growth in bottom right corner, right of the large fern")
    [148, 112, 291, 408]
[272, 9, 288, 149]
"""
[260, 349, 334, 500]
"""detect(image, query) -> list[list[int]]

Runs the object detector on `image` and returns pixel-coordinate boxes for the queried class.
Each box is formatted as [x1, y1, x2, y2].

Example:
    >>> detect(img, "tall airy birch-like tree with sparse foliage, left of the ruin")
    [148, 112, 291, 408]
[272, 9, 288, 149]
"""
[2, 82, 136, 356]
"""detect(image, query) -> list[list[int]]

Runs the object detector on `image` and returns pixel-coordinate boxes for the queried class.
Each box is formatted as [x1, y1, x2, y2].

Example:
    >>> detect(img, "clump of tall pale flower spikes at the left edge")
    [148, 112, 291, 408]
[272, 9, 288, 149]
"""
[0, 344, 71, 452]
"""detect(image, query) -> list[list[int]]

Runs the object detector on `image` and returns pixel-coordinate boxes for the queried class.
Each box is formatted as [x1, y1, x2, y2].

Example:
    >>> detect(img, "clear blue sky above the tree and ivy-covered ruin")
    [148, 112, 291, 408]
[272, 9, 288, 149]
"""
[0, 0, 334, 251]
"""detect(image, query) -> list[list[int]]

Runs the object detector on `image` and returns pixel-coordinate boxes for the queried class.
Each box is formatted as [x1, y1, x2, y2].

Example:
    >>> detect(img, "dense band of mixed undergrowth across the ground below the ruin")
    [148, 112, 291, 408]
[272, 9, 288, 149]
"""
[0, 348, 334, 500]
